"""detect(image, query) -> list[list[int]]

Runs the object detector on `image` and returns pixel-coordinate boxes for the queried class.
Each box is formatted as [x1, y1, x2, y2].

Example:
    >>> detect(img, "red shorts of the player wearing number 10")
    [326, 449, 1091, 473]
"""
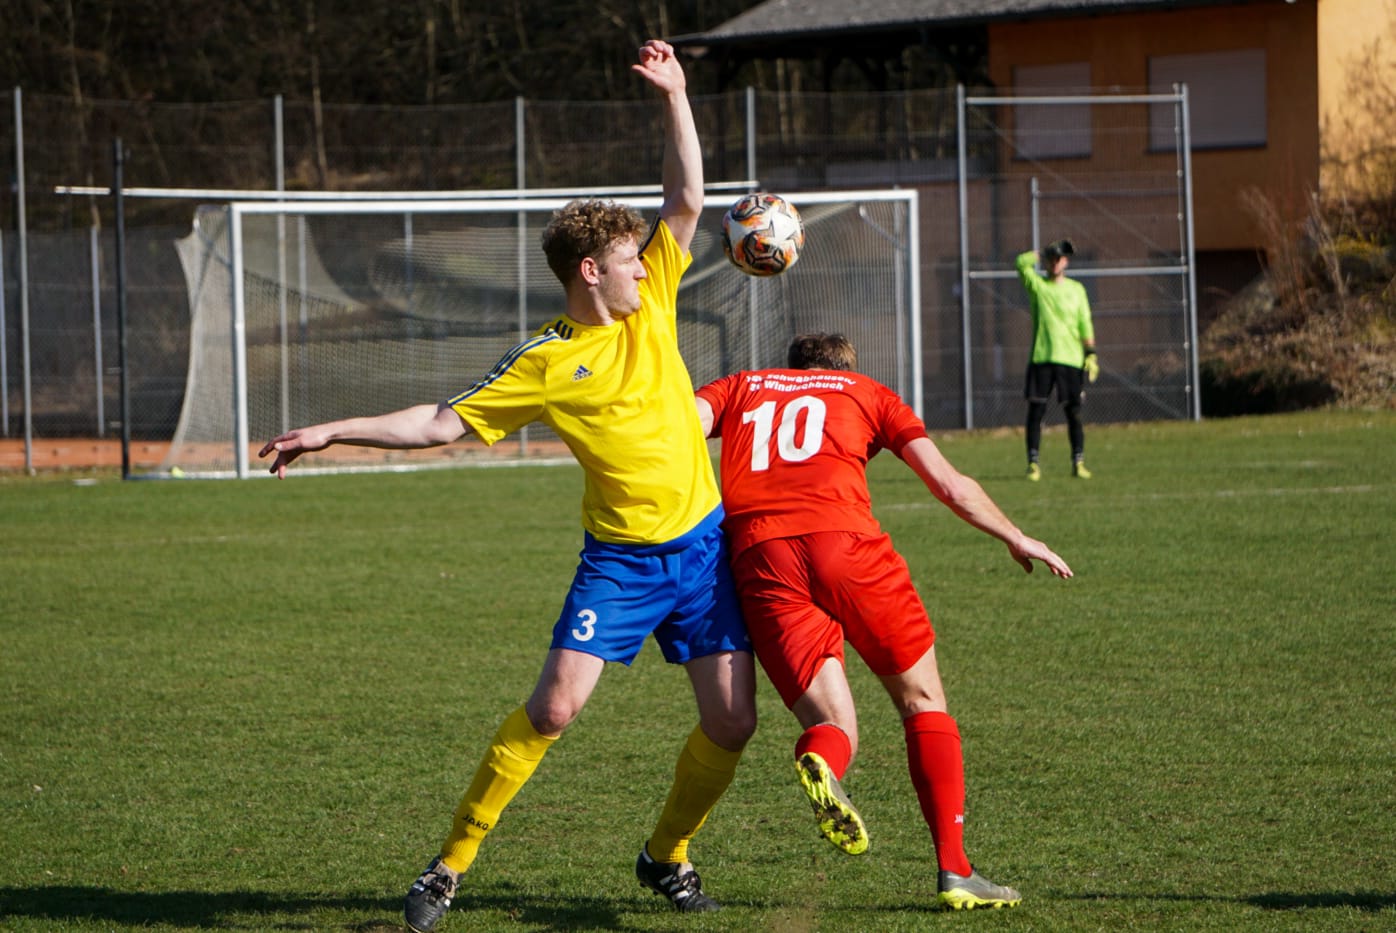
[732, 531, 935, 707]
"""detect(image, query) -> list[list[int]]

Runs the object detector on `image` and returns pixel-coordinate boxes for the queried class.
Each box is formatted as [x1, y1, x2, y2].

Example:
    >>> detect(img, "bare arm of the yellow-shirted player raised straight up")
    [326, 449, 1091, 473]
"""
[631, 39, 702, 251]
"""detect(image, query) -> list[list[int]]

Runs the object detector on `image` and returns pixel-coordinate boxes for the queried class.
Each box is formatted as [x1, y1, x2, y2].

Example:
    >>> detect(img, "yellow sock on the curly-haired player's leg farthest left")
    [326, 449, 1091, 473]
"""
[441, 707, 557, 872]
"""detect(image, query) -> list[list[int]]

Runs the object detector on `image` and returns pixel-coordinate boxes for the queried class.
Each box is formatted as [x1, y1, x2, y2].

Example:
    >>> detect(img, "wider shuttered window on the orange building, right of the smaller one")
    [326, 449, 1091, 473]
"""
[1149, 49, 1266, 149]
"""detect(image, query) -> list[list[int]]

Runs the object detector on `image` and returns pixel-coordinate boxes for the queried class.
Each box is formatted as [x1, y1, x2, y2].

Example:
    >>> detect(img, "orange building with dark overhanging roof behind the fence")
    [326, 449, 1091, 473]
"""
[677, 0, 1396, 307]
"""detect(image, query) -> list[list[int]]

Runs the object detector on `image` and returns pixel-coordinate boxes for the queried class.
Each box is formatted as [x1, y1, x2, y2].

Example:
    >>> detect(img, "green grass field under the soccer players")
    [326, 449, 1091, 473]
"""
[0, 411, 1396, 933]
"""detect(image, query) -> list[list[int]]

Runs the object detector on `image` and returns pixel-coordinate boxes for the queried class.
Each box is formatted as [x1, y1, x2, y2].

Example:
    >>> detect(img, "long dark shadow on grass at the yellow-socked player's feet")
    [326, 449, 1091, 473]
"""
[0, 886, 620, 933]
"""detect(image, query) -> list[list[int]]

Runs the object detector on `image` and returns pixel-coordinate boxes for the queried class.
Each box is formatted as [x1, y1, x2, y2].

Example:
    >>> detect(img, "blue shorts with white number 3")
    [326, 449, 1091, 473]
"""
[553, 506, 751, 665]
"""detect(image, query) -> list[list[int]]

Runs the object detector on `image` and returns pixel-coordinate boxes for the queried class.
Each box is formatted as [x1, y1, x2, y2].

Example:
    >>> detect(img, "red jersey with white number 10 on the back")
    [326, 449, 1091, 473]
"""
[698, 369, 926, 554]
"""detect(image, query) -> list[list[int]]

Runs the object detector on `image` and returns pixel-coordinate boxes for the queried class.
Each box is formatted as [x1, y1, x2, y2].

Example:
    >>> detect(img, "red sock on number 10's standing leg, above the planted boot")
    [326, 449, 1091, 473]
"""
[902, 712, 973, 874]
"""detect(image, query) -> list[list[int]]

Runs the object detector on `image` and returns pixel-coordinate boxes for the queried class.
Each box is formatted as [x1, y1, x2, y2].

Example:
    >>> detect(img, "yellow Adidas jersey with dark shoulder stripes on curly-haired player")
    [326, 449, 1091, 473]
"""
[448, 221, 722, 545]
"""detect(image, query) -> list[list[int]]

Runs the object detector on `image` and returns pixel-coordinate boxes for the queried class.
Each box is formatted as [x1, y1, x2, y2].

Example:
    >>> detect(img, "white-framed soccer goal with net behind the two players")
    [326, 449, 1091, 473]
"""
[163, 190, 921, 478]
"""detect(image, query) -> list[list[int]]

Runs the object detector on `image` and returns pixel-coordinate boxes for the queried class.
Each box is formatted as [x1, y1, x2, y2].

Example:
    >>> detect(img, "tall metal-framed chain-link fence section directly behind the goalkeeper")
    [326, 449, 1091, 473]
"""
[951, 92, 1198, 425]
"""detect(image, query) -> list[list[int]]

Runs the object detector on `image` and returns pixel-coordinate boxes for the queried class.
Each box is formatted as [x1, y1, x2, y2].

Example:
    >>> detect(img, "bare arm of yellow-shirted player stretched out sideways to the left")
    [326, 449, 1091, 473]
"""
[257, 402, 470, 479]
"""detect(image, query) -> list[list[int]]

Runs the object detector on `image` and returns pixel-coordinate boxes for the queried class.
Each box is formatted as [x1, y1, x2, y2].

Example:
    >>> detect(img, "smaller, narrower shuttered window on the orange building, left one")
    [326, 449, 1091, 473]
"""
[1013, 61, 1090, 159]
